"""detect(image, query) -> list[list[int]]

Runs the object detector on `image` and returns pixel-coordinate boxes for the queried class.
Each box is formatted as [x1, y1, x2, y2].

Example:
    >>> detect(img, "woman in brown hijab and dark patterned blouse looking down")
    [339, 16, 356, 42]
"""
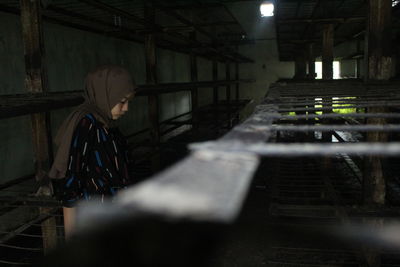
[49, 65, 135, 238]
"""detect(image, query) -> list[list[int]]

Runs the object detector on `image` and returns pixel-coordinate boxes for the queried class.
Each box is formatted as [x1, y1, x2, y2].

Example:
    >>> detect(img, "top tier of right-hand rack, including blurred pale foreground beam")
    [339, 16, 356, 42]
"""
[64, 79, 400, 222]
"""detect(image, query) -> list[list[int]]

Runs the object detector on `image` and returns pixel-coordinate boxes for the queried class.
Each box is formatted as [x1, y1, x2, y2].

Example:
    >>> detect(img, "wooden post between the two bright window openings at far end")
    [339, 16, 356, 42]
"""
[322, 24, 334, 80]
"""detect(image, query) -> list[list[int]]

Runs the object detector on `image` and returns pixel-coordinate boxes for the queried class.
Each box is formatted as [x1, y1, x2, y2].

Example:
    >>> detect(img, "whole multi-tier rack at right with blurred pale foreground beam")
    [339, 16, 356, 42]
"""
[6, 82, 400, 266]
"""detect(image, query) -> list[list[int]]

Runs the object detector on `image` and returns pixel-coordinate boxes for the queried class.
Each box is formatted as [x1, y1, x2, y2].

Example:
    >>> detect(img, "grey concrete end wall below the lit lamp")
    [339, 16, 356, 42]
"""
[228, 1, 294, 118]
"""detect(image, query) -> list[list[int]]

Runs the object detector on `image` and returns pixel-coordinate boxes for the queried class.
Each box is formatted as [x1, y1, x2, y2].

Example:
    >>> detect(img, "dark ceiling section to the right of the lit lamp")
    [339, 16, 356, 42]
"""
[275, 0, 400, 61]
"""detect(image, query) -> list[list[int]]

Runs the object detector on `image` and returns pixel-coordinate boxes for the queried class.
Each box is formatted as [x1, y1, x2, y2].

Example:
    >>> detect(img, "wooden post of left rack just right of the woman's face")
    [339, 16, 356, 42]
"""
[144, 4, 160, 171]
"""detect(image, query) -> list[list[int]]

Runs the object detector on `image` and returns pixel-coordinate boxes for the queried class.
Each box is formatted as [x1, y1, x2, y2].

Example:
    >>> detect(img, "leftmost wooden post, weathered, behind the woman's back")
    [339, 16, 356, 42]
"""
[20, 0, 57, 253]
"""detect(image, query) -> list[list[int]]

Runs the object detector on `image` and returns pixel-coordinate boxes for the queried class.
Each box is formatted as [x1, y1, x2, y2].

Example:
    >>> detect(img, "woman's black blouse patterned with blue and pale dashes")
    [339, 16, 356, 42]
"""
[55, 114, 132, 207]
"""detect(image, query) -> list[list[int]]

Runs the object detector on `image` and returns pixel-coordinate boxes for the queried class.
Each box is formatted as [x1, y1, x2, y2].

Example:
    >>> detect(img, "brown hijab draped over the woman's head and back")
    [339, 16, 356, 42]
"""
[49, 65, 136, 179]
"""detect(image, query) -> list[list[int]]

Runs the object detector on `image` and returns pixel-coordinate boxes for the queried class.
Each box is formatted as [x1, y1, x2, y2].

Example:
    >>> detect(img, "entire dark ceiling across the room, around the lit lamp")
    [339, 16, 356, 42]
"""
[0, 0, 400, 62]
